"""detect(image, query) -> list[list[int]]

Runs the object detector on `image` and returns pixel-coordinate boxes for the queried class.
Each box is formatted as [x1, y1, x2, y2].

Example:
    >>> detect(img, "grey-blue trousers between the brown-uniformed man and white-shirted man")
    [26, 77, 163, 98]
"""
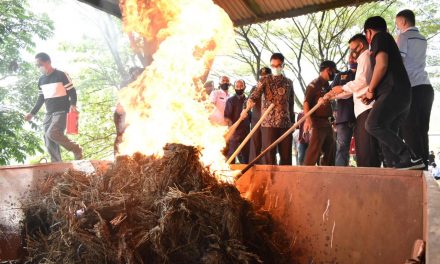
[335, 122, 354, 166]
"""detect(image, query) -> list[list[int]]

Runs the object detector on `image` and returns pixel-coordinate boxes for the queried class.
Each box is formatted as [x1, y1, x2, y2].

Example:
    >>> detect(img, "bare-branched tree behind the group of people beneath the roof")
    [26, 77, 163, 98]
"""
[227, 1, 394, 108]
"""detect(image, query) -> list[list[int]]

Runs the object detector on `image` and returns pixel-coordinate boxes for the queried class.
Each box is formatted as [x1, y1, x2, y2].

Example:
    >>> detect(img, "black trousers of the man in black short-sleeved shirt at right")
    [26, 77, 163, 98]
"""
[365, 94, 411, 167]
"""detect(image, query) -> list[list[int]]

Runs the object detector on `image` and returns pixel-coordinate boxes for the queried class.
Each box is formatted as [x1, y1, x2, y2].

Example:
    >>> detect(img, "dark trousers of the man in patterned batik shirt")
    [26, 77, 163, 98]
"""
[261, 127, 293, 165]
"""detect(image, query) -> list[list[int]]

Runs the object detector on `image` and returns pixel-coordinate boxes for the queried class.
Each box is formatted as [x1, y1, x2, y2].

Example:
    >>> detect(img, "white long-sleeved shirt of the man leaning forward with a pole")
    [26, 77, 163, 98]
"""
[337, 50, 373, 117]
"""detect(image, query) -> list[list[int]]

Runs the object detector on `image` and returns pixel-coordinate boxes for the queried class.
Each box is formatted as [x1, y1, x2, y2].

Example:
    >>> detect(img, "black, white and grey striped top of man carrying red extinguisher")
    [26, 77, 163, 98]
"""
[31, 69, 77, 115]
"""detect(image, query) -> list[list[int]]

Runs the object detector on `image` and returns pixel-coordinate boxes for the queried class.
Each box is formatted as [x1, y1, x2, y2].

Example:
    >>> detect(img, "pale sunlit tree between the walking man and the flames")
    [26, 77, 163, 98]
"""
[55, 5, 137, 160]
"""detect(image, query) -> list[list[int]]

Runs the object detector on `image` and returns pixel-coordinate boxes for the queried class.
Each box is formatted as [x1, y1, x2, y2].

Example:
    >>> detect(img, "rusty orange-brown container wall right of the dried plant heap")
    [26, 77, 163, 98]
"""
[237, 166, 424, 264]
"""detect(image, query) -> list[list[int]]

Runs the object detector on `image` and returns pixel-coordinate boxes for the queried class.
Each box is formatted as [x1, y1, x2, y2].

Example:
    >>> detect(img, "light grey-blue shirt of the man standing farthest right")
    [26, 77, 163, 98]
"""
[396, 27, 430, 87]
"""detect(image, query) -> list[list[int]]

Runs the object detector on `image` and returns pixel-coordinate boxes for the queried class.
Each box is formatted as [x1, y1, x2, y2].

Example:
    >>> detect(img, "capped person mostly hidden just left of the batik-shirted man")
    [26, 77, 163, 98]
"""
[249, 67, 272, 164]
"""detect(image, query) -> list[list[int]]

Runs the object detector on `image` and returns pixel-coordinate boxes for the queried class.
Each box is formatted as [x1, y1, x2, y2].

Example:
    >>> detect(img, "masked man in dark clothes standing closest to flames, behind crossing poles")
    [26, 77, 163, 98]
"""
[225, 80, 250, 164]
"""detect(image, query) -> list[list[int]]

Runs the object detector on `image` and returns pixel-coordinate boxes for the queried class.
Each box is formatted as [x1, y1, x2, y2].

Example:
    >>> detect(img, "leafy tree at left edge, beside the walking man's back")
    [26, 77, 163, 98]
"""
[0, 0, 53, 165]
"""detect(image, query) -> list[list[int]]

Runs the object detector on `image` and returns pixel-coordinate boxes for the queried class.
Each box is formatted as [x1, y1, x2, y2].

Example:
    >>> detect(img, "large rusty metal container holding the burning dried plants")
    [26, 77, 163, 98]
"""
[0, 161, 440, 264]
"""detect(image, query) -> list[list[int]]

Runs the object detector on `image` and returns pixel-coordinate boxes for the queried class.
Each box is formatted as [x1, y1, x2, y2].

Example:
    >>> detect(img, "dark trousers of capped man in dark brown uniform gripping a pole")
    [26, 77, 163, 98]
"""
[304, 124, 336, 166]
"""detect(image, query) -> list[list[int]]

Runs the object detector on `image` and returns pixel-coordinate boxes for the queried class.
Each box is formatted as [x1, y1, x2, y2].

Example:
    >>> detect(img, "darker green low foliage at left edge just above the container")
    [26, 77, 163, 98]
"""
[0, 109, 43, 165]
